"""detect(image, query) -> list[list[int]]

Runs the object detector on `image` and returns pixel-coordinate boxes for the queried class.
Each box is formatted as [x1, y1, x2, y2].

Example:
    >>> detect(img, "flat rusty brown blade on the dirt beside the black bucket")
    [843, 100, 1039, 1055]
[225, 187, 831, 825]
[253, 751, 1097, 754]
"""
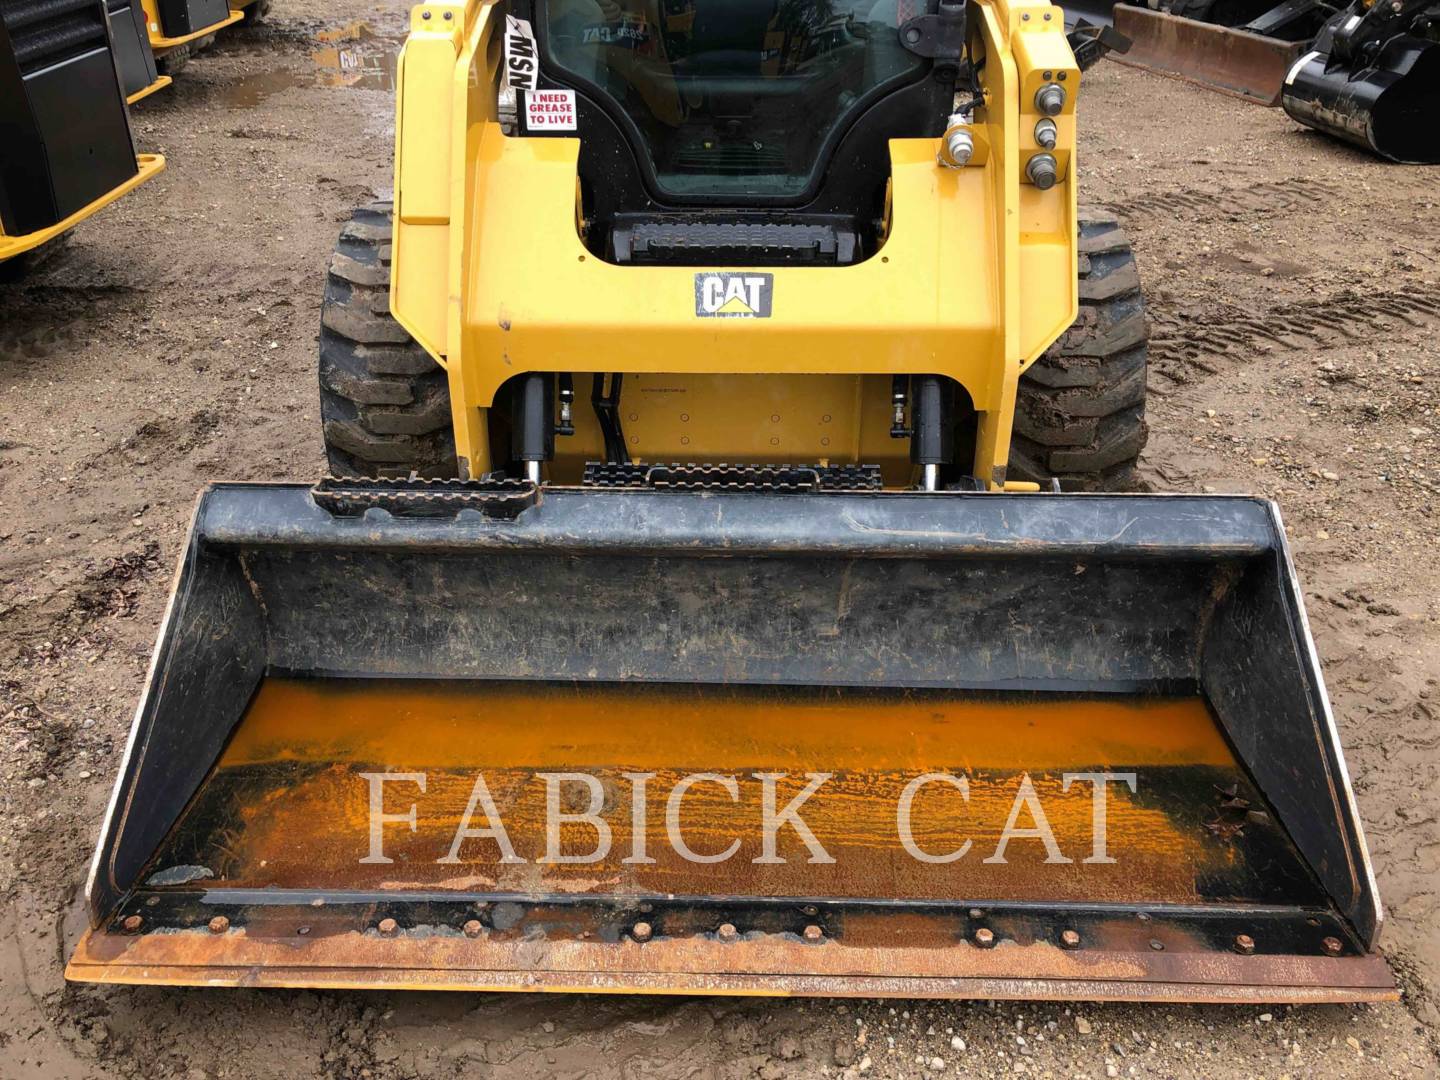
[1113, 4, 1305, 105]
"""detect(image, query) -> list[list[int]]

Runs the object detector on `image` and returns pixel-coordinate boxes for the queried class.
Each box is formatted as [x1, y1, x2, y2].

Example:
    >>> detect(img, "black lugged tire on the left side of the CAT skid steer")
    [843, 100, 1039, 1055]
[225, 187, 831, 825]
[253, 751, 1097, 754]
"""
[320, 202, 458, 478]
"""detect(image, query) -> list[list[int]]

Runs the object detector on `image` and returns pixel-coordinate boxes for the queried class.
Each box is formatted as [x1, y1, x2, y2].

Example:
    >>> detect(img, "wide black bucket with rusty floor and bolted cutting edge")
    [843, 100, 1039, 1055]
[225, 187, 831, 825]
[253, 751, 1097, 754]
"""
[68, 482, 1394, 1002]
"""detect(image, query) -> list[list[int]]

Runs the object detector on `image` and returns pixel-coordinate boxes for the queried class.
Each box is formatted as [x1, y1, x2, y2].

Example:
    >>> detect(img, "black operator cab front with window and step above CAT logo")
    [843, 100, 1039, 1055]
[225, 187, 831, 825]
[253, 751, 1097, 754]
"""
[510, 0, 971, 266]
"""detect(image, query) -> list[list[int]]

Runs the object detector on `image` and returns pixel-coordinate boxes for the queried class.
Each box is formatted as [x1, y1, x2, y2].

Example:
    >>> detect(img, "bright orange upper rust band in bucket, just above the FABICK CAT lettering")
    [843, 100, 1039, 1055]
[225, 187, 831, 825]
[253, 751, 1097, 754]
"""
[222, 678, 1234, 772]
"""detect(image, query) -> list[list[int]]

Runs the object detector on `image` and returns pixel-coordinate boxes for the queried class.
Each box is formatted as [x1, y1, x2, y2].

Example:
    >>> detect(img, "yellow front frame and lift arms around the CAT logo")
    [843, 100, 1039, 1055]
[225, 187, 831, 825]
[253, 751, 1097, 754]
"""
[390, 0, 1080, 488]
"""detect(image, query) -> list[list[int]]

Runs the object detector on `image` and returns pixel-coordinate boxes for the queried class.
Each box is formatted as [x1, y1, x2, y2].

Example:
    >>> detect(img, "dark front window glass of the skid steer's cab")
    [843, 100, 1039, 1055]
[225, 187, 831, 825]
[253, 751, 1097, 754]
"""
[540, 0, 924, 197]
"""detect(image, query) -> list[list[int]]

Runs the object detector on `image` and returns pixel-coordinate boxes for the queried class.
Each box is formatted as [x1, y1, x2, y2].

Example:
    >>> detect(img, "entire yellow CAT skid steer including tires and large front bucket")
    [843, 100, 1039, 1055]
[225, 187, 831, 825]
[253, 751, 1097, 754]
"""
[68, 0, 1395, 1002]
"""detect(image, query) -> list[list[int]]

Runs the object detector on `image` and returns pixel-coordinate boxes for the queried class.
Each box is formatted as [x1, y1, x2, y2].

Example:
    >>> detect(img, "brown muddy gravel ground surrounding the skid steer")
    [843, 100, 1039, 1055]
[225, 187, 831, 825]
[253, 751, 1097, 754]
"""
[0, 0, 1440, 1080]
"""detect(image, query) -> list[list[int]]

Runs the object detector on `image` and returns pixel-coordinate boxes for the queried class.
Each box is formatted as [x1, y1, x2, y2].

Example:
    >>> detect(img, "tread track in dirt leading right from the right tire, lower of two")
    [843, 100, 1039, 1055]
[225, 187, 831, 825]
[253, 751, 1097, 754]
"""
[1148, 285, 1440, 397]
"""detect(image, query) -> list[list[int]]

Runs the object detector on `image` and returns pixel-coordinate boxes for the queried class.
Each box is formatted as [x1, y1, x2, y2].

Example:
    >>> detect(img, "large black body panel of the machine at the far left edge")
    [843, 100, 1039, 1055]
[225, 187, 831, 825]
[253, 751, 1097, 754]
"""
[0, 0, 137, 236]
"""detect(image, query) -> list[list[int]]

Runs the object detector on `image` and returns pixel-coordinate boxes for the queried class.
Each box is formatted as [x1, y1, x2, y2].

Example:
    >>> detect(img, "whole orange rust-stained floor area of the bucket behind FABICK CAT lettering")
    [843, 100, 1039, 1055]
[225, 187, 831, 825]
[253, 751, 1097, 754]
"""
[149, 678, 1236, 903]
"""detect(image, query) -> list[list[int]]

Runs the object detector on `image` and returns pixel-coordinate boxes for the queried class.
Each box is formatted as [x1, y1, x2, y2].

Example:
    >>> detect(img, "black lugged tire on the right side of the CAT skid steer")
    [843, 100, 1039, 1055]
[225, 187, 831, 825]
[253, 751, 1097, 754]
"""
[1007, 212, 1149, 491]
